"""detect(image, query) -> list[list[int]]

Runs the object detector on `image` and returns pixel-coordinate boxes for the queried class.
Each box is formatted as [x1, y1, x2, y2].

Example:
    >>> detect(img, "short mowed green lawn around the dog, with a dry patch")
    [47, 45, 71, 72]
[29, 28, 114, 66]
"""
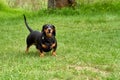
[0, 14, 120, 80]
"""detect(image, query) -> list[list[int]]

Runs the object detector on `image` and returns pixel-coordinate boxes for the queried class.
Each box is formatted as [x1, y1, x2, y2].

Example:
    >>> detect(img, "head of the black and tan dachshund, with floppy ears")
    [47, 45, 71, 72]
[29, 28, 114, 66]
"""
[42, 24, 56, 38]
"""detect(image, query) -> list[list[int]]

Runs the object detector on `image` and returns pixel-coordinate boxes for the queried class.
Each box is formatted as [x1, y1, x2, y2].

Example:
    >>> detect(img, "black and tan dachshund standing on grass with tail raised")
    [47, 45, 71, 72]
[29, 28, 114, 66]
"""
[23, 15, 57, 57]
